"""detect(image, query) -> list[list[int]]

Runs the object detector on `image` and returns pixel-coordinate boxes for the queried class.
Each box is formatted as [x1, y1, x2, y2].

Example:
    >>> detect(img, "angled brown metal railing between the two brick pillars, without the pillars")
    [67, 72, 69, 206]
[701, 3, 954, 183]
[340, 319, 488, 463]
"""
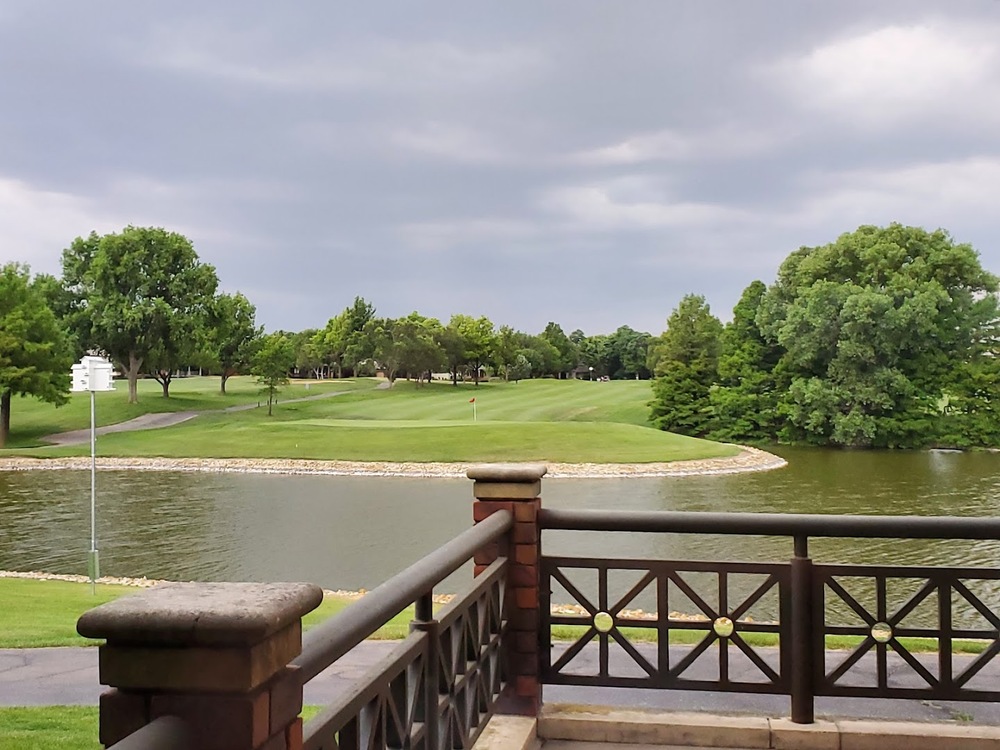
[292, 511, 513, 750]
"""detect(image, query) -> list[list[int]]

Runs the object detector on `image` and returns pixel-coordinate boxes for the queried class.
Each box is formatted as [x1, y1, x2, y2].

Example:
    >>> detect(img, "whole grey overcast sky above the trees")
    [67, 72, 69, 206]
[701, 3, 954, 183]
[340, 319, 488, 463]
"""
[0, 0, 1000, 334]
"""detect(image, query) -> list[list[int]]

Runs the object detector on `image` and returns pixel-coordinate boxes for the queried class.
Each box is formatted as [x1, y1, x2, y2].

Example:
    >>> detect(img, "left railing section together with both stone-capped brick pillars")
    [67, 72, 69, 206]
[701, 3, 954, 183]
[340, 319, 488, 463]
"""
[77, 467, 544, 750]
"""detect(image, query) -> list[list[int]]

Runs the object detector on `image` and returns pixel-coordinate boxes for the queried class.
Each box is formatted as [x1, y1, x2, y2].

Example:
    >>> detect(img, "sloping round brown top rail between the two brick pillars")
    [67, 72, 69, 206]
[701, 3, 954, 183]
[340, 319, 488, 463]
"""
[292, 510, 514, 682]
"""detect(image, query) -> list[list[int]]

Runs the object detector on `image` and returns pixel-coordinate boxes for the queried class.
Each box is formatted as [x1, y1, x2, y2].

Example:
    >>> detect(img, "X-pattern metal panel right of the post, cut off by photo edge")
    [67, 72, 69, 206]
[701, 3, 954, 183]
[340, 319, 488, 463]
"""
[812, 565, 1000, 700]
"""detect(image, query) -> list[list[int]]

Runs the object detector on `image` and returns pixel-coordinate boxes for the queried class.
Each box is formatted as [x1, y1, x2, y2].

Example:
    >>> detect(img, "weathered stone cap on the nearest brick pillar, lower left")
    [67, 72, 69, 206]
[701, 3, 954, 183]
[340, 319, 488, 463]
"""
[76, 583, 323, 646]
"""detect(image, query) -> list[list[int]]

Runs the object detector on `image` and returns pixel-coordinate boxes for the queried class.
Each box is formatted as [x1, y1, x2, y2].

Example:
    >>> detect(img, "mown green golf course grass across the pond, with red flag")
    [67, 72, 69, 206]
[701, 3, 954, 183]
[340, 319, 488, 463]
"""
[0, 377, 756, 464]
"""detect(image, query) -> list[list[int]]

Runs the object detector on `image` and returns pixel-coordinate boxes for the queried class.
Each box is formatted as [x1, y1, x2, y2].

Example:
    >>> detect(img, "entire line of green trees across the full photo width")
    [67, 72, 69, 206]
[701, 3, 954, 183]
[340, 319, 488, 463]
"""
[7, 224, 1000, 448]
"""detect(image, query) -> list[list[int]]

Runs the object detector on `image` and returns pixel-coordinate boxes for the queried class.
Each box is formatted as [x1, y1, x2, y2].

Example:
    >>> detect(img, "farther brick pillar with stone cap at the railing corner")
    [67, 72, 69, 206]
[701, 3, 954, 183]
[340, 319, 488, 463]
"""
[467, 464, 546, 716]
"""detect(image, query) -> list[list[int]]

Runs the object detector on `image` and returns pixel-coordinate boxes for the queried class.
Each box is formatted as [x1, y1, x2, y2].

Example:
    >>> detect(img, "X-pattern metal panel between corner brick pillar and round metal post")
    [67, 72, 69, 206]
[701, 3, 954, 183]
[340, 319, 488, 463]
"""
[540, 557, 788, 693]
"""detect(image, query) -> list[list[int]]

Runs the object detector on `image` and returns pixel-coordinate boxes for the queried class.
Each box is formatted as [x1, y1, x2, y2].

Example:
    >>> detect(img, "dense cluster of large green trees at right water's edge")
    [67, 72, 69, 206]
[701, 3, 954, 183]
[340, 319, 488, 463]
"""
[650, 224, 1000, 448]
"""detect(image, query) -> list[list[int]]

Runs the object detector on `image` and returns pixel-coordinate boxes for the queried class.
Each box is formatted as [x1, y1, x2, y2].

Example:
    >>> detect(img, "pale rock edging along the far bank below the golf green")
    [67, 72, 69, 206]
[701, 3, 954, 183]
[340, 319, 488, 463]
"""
[0, 446, 787, 479]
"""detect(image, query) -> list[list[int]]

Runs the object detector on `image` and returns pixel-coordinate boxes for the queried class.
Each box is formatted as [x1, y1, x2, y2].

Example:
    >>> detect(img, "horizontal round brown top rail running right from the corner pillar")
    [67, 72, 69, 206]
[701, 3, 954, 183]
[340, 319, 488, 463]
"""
[538, 508, 1000, 539]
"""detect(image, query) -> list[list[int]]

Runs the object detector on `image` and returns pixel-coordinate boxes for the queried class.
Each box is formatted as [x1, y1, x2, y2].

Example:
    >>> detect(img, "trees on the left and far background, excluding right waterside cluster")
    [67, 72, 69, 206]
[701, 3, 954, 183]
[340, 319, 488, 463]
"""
[0, 226, 652, 447]
